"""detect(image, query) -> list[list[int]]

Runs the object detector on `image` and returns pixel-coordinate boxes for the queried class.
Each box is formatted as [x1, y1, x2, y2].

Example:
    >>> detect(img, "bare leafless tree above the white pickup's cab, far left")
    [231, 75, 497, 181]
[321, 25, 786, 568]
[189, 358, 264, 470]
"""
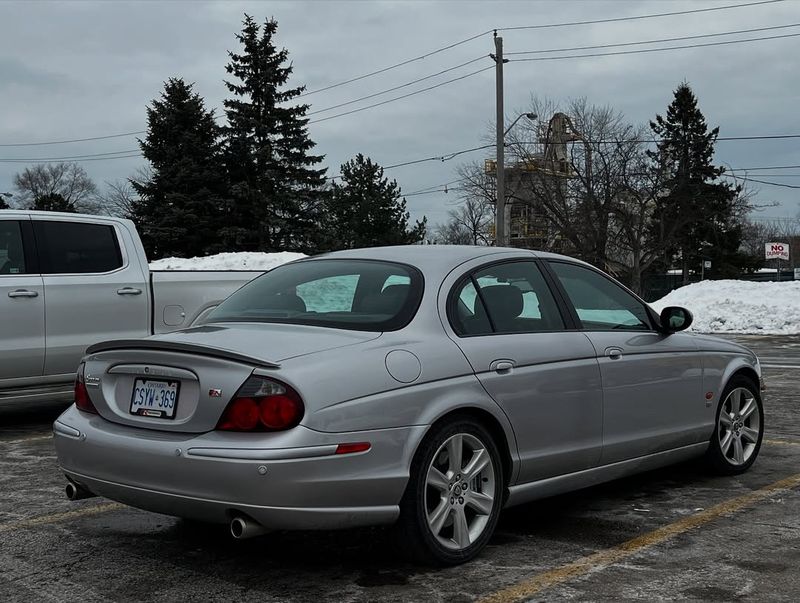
[14, 163, 99, 213]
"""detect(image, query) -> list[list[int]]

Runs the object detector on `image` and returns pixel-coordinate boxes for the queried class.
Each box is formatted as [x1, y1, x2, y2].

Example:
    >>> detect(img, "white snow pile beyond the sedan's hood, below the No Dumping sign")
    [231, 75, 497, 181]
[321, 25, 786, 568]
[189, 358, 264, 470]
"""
[650, 280, 800, 335]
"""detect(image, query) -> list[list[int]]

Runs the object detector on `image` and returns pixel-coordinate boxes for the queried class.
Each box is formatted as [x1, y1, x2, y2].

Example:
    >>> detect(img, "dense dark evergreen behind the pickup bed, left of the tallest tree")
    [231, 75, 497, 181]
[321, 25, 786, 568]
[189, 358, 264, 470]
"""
[130, 78, 226, 259]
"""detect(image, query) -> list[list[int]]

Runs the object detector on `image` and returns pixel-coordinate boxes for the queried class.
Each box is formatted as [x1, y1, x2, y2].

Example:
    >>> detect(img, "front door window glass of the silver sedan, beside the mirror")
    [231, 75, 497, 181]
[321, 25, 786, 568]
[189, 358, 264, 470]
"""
[550, 262, 653, 331]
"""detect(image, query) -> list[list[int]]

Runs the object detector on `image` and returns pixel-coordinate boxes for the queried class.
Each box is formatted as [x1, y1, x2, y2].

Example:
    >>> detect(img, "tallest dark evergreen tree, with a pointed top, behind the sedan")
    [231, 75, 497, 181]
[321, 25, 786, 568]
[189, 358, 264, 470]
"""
[223, 15, 325, 252]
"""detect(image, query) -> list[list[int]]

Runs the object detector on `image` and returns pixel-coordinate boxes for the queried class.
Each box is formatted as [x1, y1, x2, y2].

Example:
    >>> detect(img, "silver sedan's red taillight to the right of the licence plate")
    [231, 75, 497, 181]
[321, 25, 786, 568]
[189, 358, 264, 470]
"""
[217, 376, 305, 431]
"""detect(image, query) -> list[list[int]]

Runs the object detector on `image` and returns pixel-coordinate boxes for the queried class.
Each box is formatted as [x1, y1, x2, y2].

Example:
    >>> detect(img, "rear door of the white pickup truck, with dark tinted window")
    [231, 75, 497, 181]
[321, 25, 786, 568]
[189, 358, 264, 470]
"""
[33, 218, 150, 375]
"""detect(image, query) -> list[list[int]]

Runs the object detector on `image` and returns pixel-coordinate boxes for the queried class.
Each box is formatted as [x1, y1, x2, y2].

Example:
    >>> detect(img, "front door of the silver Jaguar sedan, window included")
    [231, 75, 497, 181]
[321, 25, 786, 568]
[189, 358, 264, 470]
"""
[549, 261, 708, 464]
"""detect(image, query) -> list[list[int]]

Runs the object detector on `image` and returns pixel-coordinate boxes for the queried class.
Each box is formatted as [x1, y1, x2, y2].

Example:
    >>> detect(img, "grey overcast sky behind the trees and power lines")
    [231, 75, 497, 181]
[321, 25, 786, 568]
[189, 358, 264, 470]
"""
[0, 0, 800, 223]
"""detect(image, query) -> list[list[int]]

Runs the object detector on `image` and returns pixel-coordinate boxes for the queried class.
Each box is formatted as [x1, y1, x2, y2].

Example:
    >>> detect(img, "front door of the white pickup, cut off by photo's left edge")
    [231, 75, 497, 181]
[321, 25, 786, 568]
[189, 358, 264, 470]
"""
[0, 216, 44, 389]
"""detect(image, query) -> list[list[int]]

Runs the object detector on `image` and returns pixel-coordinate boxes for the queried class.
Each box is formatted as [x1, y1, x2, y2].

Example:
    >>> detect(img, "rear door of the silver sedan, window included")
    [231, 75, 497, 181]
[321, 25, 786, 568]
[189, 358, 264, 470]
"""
[448, 261, 603, 483]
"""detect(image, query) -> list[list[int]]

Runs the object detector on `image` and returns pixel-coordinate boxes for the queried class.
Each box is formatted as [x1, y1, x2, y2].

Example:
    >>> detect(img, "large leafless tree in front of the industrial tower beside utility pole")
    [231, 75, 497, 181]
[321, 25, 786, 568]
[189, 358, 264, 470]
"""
[461, 97, 696, 290]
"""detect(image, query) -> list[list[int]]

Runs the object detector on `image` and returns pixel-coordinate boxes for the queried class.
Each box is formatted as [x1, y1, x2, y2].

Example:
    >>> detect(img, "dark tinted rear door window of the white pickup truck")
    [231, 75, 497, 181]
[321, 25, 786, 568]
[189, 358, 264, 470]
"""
[34, 220, 122, 274]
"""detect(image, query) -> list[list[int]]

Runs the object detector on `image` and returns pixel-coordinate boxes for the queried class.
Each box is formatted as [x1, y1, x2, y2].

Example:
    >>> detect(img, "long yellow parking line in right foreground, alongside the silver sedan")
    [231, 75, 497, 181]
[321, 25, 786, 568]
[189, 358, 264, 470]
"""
[479, 473, 800, 603]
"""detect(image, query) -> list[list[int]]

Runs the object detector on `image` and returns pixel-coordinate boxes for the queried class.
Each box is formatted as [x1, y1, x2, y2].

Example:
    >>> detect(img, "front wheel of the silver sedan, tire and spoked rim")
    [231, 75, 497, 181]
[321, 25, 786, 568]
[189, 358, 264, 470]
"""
[706, 375, 764, 475]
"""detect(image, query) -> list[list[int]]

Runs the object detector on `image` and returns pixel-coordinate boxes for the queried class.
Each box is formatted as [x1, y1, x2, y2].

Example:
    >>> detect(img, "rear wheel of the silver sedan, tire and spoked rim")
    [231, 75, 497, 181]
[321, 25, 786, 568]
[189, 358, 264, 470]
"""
[396, 416, 505, 566]
